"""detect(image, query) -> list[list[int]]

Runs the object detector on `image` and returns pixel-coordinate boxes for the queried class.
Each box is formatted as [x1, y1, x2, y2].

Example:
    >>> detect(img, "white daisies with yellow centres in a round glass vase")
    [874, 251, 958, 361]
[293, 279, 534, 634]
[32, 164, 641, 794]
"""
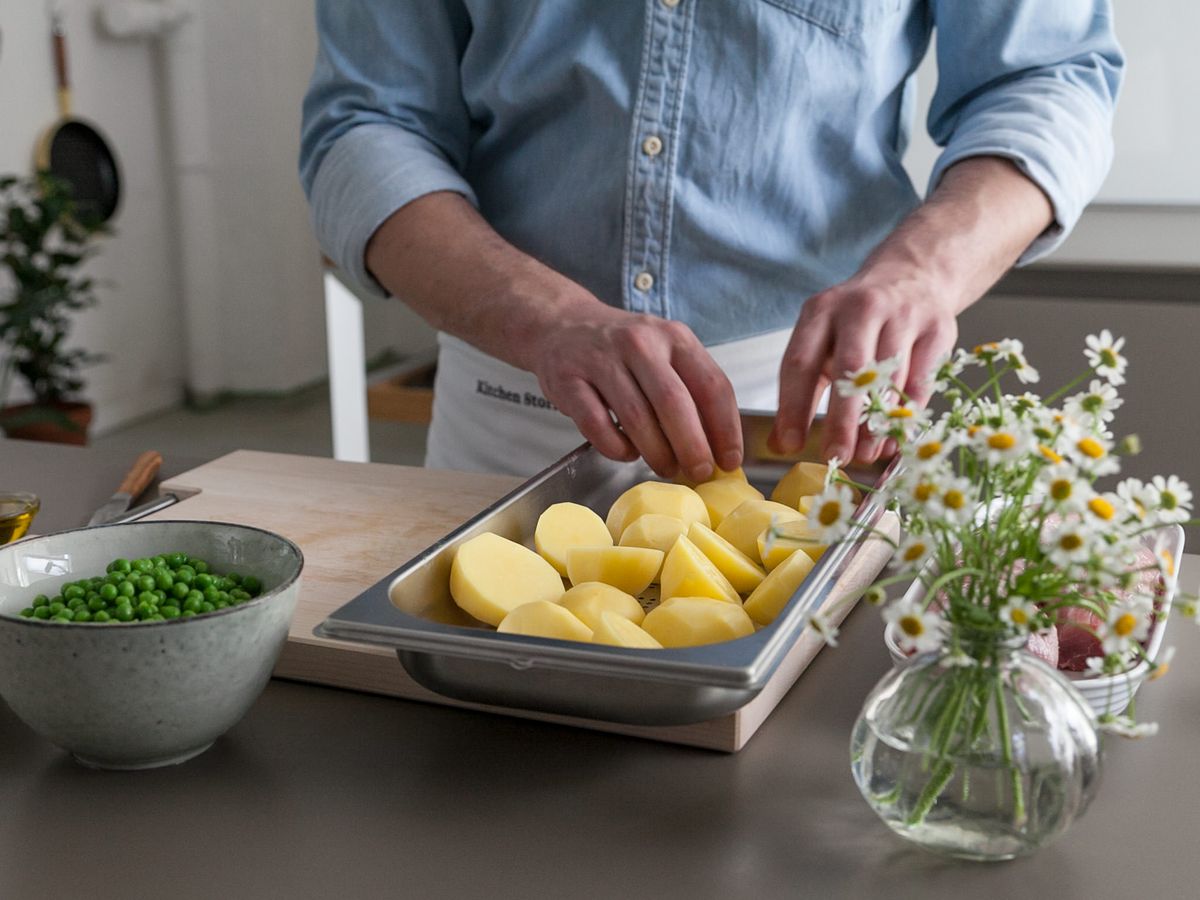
[773, 330, 1198, 859]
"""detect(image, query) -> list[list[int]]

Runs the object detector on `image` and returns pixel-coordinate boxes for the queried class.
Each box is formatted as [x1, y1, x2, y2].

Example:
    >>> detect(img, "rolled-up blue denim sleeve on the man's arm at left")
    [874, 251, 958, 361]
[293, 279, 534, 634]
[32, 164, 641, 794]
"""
[300, 0, 475, 294]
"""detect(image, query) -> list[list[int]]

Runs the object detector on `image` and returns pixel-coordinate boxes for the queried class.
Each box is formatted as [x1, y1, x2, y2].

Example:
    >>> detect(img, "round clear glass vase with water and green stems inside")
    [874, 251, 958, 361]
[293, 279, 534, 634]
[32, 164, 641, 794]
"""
[851, 641, 1100, 859]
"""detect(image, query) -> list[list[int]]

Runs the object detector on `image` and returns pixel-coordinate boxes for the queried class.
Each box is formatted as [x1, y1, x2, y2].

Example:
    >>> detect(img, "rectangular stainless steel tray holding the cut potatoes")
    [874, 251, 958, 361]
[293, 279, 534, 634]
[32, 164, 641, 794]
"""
[316, 413, 884, 725]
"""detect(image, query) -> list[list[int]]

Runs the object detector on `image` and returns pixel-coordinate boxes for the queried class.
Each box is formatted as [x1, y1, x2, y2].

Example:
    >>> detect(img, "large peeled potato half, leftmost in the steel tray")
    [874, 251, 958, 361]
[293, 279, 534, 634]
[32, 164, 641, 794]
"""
[450, 532, 563, 625]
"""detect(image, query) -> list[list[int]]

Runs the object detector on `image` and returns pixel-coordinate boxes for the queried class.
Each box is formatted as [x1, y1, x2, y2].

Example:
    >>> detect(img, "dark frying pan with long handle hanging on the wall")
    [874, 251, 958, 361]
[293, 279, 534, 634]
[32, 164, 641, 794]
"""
[35, 12, 121, 223]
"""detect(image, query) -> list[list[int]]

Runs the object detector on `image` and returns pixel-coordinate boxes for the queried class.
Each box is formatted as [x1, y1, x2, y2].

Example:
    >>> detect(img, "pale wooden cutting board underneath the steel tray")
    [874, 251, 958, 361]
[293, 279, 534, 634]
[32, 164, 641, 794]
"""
[151, 450, 896, 751]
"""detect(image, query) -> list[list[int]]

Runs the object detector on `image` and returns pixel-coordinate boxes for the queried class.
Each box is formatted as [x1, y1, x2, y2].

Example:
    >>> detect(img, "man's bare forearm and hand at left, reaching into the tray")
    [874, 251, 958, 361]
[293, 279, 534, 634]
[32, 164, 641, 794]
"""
[366, 192, 743, 481]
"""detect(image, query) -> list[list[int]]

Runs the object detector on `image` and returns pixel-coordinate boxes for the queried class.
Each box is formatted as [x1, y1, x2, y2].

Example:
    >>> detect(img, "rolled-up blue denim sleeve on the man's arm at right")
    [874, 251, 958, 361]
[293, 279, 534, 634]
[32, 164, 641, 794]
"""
[929, 0, 1124, 264]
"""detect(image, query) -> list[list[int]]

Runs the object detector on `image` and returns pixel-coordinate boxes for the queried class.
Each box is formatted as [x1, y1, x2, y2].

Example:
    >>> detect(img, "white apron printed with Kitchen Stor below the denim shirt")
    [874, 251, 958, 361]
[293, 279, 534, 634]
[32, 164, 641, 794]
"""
[425, 329, 825, 478]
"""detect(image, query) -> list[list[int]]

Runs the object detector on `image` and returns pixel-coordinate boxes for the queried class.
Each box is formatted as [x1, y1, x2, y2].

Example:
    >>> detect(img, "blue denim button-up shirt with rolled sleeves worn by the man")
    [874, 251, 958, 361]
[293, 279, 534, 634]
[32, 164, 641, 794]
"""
[300, 0, 1123, 344]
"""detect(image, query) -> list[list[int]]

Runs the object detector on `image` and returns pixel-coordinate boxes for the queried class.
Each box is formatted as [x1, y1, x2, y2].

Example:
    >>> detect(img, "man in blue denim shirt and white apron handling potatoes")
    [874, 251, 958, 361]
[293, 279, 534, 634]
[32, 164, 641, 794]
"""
[301, 0, 1123, 479]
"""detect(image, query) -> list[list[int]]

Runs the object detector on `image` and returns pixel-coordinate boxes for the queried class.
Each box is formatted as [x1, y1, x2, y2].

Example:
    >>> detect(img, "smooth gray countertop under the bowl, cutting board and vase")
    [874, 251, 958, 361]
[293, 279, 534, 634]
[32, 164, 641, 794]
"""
[0, 442, 1200, 900]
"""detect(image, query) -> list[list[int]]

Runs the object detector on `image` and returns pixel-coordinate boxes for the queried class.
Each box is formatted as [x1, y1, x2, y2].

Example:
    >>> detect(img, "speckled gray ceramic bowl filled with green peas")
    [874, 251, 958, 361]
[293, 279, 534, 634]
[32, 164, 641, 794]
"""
[0, 521, 304, 769]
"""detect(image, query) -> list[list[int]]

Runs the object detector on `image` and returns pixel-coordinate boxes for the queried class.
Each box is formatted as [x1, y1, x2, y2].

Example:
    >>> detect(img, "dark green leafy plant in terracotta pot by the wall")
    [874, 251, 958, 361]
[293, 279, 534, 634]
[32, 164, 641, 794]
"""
[0, 172, 103, 444]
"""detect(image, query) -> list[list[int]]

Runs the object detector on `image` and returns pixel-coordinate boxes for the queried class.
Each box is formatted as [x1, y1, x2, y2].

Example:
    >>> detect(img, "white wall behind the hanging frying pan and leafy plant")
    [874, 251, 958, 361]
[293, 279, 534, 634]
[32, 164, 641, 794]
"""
[0, 0, 432, 432]
